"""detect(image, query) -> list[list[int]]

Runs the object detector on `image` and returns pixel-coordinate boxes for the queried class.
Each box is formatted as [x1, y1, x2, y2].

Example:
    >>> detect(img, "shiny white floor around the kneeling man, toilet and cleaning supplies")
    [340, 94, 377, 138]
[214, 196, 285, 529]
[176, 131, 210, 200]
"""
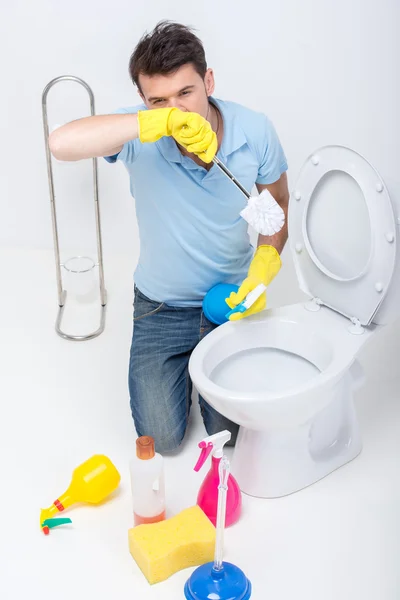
[0, 249, 400, 600]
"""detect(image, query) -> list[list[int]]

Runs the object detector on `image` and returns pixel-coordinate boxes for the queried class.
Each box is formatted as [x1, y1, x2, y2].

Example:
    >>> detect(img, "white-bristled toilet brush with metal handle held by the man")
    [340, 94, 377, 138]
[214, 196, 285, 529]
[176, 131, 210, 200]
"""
[213, 156, 285, 235]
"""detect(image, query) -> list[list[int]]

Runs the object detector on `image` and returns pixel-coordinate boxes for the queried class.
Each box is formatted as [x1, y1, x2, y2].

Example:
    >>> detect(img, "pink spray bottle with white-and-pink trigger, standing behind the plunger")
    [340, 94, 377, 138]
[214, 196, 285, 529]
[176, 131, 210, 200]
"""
[194, 431, 242, 527]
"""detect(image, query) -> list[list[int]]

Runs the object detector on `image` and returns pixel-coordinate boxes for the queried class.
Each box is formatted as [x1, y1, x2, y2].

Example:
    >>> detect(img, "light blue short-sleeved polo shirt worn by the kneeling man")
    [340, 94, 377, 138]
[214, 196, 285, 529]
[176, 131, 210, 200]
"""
[105, 98, 287, 307]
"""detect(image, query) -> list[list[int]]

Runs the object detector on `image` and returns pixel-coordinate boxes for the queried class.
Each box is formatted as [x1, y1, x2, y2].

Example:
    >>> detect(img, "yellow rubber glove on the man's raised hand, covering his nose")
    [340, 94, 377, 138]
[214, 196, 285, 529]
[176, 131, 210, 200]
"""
[137, 107, 218, 163]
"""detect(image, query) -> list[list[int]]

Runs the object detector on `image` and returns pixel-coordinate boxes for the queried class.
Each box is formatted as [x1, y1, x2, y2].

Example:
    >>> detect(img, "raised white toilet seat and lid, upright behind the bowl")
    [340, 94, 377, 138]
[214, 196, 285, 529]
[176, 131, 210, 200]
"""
[288, 146, 397, 325]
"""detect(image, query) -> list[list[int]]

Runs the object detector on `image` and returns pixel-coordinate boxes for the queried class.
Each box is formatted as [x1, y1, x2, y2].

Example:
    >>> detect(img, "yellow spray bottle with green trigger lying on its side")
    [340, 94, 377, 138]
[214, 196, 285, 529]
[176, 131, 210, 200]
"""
[40, 454, 121, 535]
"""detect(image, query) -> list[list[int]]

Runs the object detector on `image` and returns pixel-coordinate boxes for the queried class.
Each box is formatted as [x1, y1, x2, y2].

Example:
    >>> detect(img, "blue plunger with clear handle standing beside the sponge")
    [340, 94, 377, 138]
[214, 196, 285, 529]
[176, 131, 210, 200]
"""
[185, 456, 251, 600]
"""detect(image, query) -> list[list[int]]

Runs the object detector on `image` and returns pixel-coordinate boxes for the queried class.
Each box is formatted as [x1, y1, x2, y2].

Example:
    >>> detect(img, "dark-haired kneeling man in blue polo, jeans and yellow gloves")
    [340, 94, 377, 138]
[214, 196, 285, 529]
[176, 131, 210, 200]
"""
[50, 21, 289, 453]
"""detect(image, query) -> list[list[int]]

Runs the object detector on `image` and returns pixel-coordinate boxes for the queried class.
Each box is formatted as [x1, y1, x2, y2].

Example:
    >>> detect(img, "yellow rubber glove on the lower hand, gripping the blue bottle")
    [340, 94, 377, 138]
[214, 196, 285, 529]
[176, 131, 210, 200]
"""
[225, 246, 282, 321]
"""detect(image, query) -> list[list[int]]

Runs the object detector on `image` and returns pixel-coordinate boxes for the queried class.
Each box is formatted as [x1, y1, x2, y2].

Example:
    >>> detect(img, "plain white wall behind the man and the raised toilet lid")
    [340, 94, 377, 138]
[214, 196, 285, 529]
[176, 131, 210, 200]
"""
[0, 0, 400, 259]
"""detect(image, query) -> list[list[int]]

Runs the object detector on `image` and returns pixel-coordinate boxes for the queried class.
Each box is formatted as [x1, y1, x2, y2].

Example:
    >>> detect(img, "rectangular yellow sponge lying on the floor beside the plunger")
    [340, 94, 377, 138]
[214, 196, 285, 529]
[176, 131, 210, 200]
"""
[128, 506, 215, 583]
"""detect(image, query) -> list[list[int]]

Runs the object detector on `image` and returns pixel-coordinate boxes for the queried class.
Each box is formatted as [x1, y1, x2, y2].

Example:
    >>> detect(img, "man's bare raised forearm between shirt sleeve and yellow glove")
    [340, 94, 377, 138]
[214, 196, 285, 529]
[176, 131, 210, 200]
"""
[49, 114, 139, 161]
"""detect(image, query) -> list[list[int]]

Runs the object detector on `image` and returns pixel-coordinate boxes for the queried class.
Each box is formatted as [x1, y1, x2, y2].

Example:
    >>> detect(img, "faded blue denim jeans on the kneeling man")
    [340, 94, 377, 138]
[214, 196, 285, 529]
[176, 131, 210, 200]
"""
[129, 286, 239, 454]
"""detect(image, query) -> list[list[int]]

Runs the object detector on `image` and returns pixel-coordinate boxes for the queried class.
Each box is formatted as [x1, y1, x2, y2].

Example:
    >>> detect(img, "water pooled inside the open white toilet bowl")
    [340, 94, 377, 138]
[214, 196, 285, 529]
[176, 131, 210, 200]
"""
[210, 347, 320, 393]
